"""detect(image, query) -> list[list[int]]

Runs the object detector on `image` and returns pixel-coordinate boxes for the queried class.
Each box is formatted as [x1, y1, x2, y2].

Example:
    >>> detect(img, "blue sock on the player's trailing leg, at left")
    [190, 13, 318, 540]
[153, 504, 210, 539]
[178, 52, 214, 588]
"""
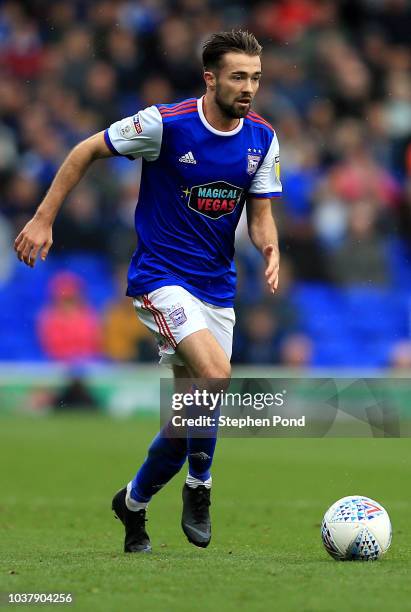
[130, 426, 187, 503]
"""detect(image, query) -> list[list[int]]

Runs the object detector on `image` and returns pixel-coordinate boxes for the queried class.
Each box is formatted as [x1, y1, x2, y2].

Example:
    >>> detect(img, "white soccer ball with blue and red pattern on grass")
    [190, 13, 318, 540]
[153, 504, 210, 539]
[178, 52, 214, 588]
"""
[321, 495, 391, 561]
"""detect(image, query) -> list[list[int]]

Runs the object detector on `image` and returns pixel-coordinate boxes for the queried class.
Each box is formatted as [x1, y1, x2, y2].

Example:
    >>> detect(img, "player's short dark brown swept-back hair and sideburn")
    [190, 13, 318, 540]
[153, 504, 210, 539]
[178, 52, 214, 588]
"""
[203, 30, 263, 70]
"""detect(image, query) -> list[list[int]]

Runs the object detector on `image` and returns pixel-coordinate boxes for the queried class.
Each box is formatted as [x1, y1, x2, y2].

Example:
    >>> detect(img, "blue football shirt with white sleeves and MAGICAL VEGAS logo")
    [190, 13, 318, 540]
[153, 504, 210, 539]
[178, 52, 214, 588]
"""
[104, 98, 282, 307]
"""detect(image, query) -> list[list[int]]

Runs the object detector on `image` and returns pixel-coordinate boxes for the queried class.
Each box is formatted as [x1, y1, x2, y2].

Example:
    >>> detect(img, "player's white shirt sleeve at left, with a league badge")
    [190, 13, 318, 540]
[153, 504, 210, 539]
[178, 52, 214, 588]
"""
[104, 106, 163, 161]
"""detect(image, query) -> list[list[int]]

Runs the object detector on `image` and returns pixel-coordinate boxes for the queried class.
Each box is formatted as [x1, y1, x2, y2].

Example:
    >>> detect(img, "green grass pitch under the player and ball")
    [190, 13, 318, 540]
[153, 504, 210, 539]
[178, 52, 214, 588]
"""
[0, 416, 411, 612]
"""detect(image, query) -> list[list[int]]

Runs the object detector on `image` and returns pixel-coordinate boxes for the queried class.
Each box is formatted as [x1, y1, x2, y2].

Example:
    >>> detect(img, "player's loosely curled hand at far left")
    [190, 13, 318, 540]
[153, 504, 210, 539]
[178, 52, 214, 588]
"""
[14, 216, 53, 268]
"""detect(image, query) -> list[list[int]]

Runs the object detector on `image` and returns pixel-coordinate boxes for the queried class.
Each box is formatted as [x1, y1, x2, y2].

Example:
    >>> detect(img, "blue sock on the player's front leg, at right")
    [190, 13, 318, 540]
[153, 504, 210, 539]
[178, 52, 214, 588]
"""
[187, 410, 220, 482]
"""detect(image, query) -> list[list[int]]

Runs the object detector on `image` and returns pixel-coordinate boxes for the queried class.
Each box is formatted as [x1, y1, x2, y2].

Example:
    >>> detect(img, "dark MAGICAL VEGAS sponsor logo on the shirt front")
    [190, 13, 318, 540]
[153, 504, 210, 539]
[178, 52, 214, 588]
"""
[187, 181, 244, 219]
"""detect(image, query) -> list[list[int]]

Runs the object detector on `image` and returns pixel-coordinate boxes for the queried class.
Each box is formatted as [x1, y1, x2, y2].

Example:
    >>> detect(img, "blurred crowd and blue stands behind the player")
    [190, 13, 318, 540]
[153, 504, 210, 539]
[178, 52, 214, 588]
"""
[0, 0, 411, 413]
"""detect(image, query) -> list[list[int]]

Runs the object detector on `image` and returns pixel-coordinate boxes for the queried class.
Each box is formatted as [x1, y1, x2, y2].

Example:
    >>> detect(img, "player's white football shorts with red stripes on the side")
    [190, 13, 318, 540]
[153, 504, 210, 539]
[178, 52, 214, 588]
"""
[133, 285, 235, 365]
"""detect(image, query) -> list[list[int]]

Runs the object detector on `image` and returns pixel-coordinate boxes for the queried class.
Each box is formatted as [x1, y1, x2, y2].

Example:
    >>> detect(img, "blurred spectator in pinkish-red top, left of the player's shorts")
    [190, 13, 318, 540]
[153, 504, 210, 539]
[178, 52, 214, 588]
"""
[38, 272, 101, 362]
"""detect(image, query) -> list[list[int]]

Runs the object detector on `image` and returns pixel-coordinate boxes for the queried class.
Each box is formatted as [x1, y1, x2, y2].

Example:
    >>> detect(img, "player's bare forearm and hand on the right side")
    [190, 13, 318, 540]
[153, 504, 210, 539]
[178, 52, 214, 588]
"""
[247, 196, 280, 293]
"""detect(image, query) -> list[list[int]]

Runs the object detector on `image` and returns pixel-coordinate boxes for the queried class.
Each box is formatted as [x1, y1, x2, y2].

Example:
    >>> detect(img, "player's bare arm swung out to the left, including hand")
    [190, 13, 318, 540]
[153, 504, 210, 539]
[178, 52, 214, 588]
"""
[14, 132, 114, 268]
